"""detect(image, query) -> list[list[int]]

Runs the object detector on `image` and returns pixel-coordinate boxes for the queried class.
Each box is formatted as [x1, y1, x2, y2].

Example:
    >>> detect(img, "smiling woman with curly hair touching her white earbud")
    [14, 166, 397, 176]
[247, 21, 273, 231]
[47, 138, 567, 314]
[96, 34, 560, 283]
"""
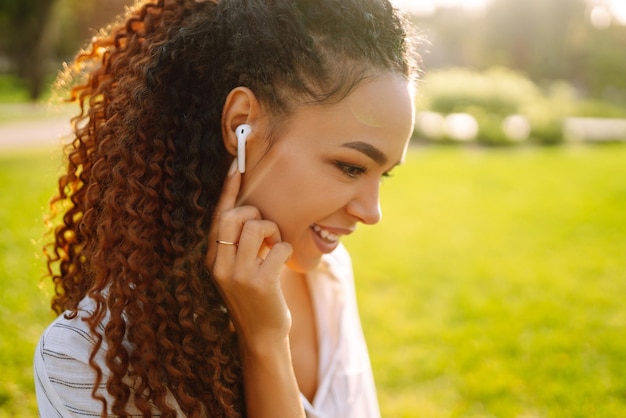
[35, 0, 416, 418]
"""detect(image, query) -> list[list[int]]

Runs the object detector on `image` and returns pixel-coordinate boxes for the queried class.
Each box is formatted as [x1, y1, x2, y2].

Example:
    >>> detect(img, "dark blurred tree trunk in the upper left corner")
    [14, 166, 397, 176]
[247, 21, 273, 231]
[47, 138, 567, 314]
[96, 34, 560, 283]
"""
[0, 0, 56, 99]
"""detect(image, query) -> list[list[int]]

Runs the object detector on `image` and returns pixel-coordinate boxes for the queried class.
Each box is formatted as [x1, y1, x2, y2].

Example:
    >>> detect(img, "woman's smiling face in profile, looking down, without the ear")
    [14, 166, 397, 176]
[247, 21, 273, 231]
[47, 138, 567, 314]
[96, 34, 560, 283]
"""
[240, 75, 414, 272]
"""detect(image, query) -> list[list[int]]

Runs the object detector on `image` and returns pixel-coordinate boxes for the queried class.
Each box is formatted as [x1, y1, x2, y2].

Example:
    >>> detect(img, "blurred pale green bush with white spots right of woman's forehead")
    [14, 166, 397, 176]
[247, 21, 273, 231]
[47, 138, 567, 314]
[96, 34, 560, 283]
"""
[415, 67, 626, 146]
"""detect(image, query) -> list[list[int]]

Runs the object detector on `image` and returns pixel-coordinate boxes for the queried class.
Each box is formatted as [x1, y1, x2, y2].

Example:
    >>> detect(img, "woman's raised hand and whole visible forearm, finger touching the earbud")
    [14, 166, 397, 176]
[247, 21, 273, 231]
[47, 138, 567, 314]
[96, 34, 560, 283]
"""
[206, 160, 305, 418]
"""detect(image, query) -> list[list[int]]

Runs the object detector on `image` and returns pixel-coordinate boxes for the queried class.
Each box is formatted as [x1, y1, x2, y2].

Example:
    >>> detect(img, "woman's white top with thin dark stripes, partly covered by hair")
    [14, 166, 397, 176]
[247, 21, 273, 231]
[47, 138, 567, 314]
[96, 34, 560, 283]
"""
[34, 246, 380, 418]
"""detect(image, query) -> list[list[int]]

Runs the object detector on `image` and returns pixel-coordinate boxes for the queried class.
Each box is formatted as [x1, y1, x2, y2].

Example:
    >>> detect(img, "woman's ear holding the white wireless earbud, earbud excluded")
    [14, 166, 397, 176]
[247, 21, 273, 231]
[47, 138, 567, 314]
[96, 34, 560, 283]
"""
[222, 87, 261, 156]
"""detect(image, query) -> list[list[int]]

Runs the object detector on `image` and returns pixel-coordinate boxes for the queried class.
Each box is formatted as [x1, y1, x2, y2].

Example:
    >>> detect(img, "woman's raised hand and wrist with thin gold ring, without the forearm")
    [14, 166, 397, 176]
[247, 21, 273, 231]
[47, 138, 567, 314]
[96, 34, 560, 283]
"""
[206, 160, 292, 353]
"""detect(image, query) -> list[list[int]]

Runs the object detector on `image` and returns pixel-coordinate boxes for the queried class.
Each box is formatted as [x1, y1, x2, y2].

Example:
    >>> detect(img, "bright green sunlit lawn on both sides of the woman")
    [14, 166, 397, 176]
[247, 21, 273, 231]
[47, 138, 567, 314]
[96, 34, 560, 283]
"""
[0, 145, 626, 418]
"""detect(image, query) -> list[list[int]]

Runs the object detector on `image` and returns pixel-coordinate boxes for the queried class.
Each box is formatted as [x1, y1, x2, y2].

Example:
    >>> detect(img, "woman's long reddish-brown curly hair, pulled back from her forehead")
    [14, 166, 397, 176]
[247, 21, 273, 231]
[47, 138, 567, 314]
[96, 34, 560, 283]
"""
[46, 0, 417, 417]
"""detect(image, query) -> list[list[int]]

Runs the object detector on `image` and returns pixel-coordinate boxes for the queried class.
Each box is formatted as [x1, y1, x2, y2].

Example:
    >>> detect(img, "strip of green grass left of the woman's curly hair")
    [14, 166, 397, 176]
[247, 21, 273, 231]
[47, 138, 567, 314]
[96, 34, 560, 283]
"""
[0, 150, 59, 418]
